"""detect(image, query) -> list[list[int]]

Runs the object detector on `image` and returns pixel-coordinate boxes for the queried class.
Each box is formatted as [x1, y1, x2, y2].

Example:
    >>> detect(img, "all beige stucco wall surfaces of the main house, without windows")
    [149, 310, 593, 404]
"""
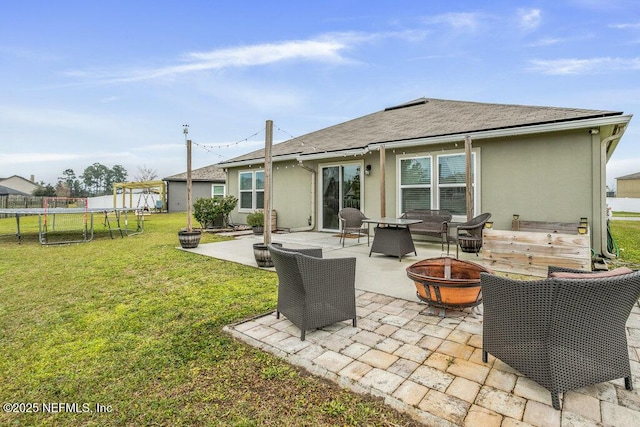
[227, 130, 601, 251]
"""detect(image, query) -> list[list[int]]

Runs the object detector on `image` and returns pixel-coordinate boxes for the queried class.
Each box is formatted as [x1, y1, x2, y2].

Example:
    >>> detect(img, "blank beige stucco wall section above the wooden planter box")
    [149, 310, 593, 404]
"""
[481, 132, 593, 229]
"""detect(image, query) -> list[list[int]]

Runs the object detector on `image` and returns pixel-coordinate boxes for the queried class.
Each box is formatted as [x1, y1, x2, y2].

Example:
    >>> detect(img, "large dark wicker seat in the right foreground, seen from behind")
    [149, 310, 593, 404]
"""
[480, 269, 640, 410]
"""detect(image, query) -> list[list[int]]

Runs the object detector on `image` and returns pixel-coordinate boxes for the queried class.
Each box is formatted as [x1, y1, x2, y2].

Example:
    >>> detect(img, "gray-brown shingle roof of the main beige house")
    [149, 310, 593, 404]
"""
[224, 98, 622, 163]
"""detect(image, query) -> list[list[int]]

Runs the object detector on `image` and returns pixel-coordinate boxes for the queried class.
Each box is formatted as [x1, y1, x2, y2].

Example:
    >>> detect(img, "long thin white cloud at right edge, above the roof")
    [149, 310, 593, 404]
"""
[530, 57, 640, 74]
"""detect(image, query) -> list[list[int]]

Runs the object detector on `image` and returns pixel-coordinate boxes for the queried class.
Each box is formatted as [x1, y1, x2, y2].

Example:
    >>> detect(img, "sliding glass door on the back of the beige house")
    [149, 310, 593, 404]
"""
[320, 164, 362, 231]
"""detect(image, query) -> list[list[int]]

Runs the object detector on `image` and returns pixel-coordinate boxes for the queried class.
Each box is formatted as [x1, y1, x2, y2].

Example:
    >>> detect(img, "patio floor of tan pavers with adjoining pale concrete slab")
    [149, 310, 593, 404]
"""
[182, 233, 640, 427]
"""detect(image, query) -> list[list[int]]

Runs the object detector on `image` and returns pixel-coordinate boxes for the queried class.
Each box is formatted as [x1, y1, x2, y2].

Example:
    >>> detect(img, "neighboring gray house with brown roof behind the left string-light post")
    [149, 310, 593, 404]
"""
[163, 165, 227, 212]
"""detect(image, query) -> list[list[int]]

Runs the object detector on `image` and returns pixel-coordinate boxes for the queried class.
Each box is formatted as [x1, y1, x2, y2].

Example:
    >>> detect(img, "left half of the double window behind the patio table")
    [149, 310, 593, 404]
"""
[400, 157, 431, 212]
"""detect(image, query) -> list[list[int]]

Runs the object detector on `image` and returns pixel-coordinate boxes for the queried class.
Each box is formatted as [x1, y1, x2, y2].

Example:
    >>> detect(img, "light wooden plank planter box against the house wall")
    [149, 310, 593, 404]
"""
[481, 221, 591, 277]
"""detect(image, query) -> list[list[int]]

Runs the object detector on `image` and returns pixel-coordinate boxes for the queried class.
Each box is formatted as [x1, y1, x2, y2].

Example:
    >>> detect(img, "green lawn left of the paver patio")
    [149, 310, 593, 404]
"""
[0, 214, 416, 426]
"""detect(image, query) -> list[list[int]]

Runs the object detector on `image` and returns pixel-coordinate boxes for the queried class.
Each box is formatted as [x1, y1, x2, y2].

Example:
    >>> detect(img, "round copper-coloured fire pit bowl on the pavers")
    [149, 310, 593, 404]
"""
[407, 257, 492, 317]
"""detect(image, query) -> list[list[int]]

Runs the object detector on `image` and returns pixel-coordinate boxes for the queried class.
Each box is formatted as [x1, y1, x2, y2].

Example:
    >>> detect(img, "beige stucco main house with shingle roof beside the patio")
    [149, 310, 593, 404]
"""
[218, 98, 632, 253]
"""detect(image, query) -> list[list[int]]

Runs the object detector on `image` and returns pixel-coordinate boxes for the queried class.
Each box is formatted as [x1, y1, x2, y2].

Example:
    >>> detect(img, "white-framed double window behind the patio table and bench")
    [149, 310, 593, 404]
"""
[398, 152, 477, 216]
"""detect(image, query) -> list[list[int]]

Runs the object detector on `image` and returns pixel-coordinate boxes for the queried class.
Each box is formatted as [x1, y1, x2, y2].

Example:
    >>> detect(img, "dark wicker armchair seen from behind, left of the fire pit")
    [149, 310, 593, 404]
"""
[268, 245, 356, 341]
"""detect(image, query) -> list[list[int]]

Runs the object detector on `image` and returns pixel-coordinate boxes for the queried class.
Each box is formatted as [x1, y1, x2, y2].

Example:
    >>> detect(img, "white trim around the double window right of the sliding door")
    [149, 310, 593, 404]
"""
[396, 147, 482, 222]
